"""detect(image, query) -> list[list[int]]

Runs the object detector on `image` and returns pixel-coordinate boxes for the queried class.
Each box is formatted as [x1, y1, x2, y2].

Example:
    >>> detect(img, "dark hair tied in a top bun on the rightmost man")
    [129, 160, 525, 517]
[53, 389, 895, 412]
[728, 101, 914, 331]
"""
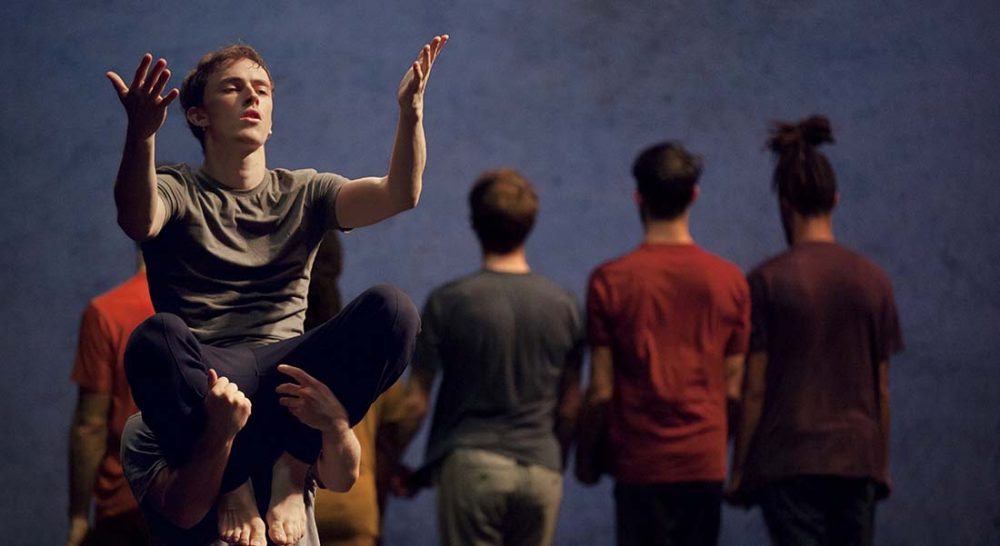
[767, 116, 837, 216]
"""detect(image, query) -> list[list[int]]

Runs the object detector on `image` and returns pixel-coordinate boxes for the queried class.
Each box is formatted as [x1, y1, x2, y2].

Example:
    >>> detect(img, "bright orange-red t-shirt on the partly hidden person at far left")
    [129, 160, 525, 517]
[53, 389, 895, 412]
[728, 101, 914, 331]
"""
[71, 273, 153, 520]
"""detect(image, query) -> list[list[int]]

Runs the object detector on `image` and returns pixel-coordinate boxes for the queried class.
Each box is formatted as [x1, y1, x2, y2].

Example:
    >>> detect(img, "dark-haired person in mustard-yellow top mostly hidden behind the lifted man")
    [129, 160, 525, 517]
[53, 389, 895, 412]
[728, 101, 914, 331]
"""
[305, 231, 409, 546]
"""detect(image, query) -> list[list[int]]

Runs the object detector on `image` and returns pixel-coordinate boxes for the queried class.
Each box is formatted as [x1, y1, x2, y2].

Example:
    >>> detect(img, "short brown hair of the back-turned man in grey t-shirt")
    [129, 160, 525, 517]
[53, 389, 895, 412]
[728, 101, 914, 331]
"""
[469, 169, 538, 254]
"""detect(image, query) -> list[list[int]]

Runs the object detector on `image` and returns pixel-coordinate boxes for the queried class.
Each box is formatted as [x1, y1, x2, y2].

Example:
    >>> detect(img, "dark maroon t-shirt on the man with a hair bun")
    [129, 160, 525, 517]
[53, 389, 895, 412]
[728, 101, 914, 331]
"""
[744, 242, 903, 493]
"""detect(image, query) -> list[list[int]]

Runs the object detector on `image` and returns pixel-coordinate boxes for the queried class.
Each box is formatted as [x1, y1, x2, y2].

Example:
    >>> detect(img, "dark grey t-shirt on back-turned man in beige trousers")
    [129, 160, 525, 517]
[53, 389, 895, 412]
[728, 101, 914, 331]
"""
[413, 270, 583, 471]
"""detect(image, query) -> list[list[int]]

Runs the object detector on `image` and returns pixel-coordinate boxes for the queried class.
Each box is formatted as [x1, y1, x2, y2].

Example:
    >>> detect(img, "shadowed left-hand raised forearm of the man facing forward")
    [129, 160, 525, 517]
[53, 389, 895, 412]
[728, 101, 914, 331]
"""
[115, 133, 159, 241]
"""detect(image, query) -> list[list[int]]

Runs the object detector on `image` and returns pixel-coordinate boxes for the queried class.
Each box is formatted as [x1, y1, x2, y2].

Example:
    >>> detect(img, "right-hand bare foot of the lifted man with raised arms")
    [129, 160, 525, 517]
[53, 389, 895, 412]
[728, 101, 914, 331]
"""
[265, 453, 309, 546]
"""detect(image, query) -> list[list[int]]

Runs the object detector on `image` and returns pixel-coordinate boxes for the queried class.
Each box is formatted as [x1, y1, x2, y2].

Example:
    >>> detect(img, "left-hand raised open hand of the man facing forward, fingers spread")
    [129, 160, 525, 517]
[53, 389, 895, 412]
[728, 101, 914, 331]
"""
[105, 53, 180, 140]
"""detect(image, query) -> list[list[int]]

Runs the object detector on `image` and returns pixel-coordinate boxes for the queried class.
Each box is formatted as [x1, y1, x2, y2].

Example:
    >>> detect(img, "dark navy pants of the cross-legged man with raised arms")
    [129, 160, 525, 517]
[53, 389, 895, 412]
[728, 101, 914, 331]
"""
[125, 285, 420, 491]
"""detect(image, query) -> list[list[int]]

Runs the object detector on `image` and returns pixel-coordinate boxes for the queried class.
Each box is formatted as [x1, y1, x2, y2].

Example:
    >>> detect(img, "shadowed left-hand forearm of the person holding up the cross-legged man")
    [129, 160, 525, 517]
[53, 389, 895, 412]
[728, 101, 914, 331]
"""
[152, 433, 233, 529]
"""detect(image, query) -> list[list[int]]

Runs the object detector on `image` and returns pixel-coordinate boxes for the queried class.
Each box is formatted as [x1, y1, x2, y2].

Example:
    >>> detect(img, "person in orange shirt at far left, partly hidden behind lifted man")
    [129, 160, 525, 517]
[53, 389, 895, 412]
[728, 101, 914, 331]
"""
[66, 261, 153, 546]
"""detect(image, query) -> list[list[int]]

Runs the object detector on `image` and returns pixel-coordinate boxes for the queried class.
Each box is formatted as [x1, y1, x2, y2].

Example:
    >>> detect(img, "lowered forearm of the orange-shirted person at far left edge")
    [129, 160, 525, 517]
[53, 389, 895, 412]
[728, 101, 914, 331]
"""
[69, 419, 107, 519]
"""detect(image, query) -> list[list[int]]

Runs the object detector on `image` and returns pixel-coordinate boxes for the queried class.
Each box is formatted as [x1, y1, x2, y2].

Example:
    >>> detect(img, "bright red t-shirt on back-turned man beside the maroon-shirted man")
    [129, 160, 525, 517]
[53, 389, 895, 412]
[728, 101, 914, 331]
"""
[587, 243, 750, 484]
